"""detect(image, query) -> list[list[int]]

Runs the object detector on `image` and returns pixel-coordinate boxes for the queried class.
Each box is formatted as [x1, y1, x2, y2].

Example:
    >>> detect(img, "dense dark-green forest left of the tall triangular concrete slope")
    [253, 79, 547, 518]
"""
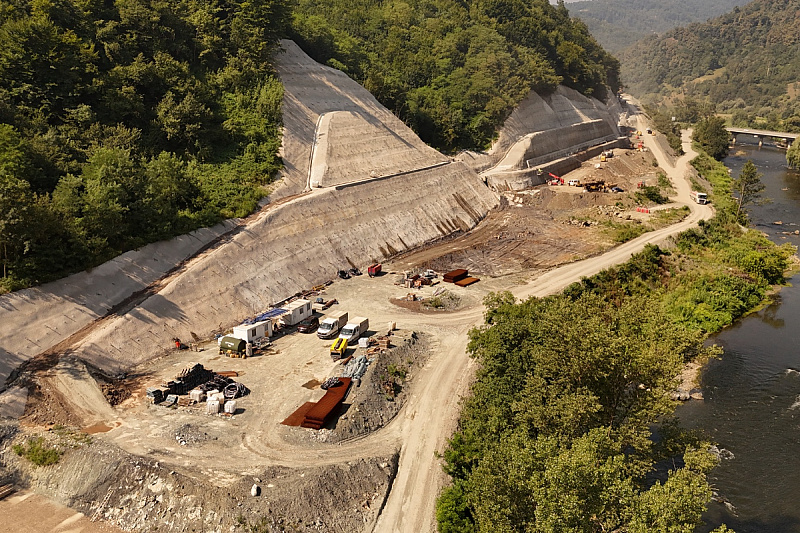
[0, 0, 290, 289]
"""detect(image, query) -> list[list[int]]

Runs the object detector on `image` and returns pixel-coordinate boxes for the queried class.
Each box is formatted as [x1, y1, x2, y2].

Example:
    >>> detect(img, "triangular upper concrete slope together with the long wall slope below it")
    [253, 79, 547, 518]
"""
[69, 42, 497, 372]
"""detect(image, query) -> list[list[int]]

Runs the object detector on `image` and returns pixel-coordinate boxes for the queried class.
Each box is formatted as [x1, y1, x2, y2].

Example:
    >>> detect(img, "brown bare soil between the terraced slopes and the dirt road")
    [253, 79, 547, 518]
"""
[393, 149, 658, 276]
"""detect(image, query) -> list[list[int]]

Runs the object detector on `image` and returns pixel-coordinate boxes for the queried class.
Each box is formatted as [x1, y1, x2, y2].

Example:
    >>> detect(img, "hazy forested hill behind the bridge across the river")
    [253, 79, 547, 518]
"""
[622, 0, 800, 131]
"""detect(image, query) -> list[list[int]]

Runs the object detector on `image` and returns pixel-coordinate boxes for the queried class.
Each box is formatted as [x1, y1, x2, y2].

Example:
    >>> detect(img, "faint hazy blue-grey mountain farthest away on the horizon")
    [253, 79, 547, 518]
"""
[567, 0, 746, 53]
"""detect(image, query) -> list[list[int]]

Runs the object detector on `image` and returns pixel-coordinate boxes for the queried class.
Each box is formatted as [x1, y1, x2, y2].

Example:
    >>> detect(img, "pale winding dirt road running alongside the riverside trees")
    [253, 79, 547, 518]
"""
[373, 116, 713, 533]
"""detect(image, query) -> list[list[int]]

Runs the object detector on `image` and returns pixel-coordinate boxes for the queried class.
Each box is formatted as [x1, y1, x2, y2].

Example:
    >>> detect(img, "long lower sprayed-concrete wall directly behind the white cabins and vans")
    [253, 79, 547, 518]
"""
[77, 162, 497, 372]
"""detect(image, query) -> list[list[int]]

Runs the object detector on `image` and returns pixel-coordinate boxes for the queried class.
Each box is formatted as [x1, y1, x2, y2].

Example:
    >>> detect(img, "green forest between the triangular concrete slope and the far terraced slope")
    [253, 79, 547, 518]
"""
[292, 0, 619, 151]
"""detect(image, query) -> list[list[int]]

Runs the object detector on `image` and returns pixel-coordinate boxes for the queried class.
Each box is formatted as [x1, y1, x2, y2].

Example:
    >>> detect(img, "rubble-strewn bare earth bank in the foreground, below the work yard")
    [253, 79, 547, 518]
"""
[0, 426, 397, 533]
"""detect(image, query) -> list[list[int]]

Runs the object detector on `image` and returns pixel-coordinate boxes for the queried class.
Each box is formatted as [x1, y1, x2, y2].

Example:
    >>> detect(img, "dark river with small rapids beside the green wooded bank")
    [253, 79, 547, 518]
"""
[678, 144, 800, 533]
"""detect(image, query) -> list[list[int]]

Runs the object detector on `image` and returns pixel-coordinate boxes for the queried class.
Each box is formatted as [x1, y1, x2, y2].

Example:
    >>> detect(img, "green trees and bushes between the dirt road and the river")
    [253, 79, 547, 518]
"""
[437, 145, 795, 533]
